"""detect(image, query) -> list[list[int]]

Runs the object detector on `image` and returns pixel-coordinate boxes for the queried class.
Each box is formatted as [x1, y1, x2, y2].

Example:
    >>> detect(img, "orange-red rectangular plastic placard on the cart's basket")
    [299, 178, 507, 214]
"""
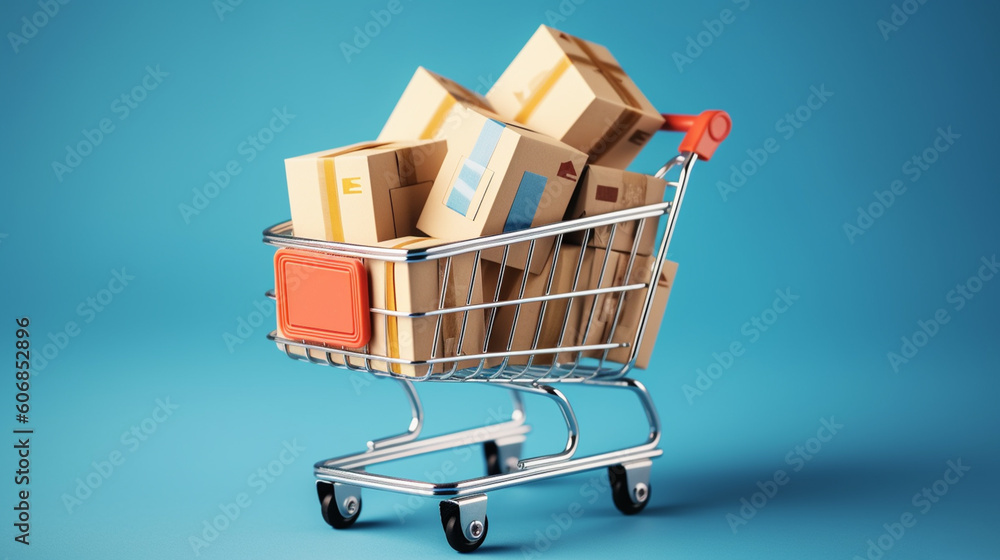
[274, 249, 371, 348]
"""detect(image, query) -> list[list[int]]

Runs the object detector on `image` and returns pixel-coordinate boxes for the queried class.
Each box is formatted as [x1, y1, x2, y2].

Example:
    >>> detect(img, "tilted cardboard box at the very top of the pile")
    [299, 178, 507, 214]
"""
[486, 25, 663, 169]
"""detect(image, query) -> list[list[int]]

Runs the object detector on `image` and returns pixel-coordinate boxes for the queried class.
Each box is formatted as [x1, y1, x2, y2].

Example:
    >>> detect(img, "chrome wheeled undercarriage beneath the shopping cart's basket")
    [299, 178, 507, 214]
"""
[315, 378, 663, 552]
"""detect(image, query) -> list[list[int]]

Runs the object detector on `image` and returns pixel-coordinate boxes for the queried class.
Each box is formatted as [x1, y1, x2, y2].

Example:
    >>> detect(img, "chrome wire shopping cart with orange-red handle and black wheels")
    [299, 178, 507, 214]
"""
[264, 111, 731, 552]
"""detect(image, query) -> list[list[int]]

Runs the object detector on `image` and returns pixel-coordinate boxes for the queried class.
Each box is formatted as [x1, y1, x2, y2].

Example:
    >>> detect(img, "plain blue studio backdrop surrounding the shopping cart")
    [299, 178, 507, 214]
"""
[0, 0, 1000, 559]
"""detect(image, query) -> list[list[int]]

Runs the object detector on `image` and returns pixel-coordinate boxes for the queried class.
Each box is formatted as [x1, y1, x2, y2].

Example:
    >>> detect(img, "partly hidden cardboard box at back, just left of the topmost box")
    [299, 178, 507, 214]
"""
[378, 66, 490, 141]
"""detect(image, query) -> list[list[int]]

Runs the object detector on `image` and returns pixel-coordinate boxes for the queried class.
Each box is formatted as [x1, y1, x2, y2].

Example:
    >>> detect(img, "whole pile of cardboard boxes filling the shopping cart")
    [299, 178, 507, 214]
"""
[278, 26, 676, 375]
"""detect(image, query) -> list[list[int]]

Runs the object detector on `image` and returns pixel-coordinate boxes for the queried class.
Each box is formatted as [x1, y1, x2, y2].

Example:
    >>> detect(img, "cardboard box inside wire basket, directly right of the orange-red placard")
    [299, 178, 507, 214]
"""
[362, 237, 485, 376]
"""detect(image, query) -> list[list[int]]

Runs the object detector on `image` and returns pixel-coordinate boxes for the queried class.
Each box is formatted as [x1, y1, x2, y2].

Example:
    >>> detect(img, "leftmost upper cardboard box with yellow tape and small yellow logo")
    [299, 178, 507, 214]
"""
[285, 140, 447, 245]
